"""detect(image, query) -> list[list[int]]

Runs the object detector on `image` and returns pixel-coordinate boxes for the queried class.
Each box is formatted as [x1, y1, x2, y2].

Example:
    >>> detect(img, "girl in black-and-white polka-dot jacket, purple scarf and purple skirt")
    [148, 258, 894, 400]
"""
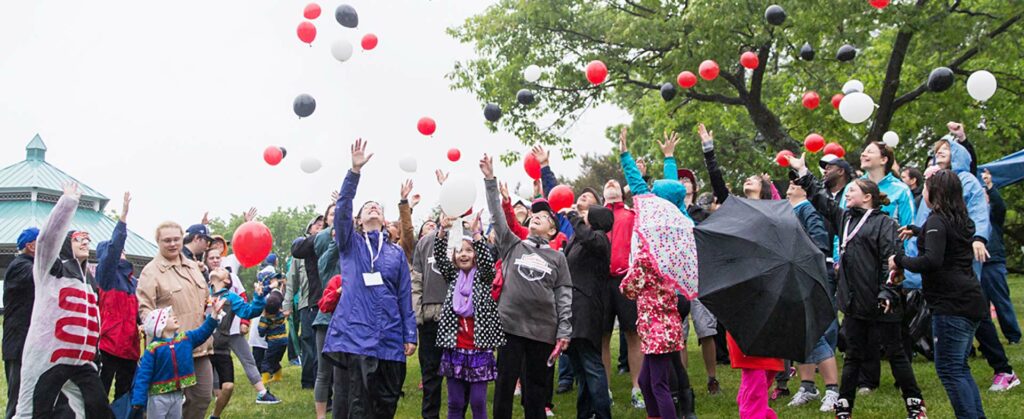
[434, 214, 505, 419]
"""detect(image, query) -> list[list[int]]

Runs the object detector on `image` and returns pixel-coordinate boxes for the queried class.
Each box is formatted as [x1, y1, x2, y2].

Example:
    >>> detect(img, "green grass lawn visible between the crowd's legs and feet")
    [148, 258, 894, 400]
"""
[0, 276, 1024, 418]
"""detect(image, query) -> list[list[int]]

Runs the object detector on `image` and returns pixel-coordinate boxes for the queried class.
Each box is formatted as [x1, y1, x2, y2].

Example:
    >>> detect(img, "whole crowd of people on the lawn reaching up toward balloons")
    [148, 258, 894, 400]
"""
[3, 123, 1021, 419]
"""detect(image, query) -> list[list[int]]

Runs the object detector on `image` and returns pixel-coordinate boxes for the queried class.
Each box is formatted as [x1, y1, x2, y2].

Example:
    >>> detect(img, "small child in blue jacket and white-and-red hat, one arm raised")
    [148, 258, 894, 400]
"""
[131, 298, 226, 419]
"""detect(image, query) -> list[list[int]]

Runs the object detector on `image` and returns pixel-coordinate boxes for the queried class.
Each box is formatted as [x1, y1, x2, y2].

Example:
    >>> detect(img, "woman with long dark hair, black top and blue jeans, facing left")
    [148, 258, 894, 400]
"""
[889, 169, 988, 418]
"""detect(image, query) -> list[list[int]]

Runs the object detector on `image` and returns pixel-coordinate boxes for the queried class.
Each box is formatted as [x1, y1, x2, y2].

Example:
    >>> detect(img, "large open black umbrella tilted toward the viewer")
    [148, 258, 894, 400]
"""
[693, 197, 836, 361]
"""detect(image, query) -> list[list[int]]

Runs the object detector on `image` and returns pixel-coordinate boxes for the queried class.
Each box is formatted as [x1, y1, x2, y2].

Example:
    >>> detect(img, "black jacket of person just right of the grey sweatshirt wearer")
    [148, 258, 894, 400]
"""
[564, 206, 614, 347]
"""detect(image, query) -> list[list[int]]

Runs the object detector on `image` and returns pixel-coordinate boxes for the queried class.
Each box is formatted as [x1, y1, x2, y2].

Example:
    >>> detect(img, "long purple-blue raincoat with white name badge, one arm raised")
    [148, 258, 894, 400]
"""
[324, 171, 417, 363]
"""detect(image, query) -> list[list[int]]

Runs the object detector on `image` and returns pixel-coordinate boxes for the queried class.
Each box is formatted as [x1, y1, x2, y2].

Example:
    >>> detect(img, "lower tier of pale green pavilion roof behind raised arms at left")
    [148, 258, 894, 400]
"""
[0, 201, 157, 258]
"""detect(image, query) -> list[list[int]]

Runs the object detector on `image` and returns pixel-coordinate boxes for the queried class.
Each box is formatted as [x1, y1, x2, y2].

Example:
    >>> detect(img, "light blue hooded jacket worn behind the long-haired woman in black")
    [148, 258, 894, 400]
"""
[903, 135, 991, 288]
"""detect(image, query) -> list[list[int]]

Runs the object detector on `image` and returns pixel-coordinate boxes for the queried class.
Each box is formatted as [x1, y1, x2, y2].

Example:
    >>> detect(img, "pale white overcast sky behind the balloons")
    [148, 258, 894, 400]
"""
[0, 0, 628, 238]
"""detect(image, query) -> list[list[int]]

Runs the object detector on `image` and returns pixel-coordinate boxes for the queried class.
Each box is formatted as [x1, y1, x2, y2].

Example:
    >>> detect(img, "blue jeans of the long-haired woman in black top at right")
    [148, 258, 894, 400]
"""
[932, 315, 985, 418]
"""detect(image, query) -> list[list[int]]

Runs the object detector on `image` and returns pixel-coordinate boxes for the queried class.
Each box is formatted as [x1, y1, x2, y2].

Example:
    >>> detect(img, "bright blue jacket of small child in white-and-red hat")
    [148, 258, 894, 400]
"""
[131, 316, 217, 406]
